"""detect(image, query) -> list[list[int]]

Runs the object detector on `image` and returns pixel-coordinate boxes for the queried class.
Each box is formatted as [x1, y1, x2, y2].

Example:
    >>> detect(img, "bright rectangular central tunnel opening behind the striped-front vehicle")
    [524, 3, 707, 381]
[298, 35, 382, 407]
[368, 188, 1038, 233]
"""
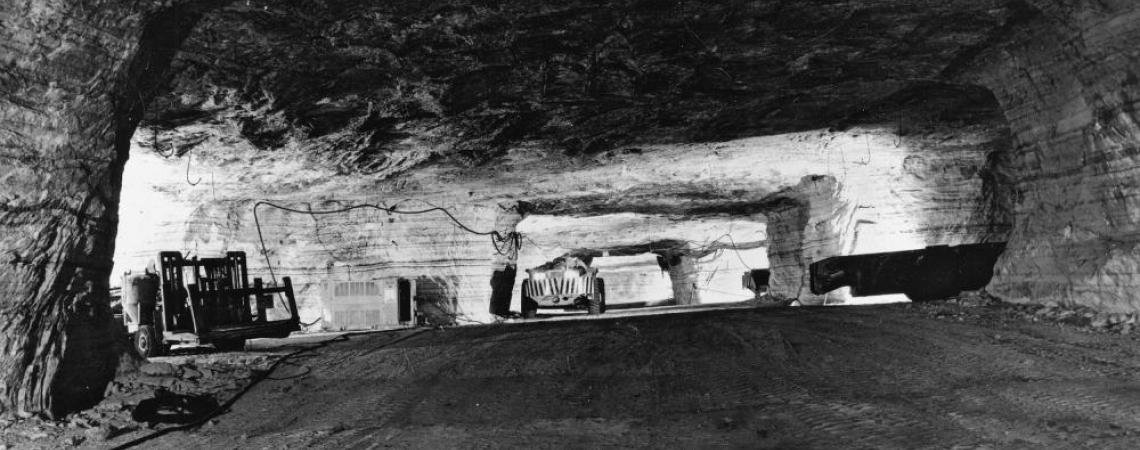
[515, 213, 767, 316]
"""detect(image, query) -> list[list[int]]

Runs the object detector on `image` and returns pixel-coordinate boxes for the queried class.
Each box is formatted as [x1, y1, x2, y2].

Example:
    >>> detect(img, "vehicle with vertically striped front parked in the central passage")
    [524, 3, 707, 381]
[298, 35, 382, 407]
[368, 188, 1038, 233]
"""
[522, 257, 605, 319]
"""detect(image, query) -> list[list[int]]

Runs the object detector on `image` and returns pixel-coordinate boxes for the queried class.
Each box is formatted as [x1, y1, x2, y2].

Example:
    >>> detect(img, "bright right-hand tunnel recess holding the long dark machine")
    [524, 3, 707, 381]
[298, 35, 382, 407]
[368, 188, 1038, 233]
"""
[760, 83, 1017, 304]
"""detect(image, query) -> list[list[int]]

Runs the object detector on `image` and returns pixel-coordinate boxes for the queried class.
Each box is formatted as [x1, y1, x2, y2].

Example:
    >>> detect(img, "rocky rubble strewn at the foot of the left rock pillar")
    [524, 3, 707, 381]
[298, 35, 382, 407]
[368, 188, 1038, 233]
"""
[0, 353, 280, 450]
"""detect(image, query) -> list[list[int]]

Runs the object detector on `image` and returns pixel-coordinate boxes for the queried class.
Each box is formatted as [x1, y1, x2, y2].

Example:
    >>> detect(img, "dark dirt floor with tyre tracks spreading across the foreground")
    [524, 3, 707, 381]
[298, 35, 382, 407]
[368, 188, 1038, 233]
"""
[5, 302, 1140, 449]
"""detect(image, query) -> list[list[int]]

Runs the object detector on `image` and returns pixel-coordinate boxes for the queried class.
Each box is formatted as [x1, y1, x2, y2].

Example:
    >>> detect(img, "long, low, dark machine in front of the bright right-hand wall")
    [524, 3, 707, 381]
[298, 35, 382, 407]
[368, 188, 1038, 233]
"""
[809, 243, 1005, 301]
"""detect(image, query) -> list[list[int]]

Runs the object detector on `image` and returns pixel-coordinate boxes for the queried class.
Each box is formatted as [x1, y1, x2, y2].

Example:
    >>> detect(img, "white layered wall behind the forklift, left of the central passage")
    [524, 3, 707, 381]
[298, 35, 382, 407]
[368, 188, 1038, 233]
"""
[113, 138, 510, 327]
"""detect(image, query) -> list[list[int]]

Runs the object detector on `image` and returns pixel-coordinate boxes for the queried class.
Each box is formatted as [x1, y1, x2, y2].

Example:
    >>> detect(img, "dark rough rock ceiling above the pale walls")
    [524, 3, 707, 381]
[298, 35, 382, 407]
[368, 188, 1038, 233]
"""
[144, 0, 1027, 177]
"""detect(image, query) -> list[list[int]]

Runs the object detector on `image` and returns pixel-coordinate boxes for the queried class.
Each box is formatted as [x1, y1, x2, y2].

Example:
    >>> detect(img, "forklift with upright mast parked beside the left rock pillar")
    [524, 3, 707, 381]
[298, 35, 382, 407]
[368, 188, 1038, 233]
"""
[121, 252, 301, 357]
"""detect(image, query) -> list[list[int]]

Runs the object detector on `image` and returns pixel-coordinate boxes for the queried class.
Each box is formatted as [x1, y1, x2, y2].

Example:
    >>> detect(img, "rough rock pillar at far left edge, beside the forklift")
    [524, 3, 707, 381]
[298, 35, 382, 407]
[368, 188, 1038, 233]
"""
[0, 0, 205, 415]
